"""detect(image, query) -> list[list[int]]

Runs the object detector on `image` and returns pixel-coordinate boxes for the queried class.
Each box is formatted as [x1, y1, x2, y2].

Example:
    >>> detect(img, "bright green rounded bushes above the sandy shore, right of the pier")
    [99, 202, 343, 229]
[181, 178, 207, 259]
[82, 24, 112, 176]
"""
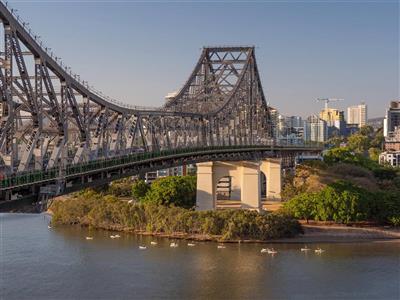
[284, 181, 400, 225]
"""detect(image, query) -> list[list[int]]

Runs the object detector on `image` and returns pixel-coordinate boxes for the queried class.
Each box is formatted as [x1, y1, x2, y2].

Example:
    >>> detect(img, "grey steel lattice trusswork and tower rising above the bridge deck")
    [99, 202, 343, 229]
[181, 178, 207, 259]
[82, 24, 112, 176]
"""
[0, 3, 271, 178]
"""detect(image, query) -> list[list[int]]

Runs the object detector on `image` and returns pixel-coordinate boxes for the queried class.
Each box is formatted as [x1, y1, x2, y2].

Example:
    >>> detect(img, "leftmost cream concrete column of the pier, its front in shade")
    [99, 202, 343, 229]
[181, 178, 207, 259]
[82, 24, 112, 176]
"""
[196, 162, 215, 210]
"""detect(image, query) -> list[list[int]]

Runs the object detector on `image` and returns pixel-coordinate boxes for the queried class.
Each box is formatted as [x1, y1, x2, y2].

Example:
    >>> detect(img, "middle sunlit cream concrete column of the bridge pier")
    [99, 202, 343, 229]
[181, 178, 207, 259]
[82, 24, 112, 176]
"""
[240, 162, 262, 211]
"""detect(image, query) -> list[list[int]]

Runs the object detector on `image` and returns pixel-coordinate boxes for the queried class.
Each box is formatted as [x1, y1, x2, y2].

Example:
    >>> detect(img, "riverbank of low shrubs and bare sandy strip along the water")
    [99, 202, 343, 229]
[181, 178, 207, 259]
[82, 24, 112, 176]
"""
[49, 195, 400, 244]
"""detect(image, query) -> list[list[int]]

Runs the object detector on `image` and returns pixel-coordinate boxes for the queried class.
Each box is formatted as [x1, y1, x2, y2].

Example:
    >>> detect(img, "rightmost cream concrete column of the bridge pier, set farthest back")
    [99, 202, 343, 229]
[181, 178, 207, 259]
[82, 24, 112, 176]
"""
[260, 158, 282, 200]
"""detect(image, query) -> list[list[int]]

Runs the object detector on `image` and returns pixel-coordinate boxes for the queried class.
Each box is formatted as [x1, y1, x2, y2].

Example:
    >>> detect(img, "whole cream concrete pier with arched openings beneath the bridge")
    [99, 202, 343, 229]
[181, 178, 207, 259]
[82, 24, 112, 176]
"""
[196, 159, 282, 211]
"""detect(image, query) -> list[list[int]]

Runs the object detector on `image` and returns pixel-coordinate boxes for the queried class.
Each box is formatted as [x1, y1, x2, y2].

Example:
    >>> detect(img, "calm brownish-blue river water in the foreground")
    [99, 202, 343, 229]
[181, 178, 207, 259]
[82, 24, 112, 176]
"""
[0, 214, 400, 299]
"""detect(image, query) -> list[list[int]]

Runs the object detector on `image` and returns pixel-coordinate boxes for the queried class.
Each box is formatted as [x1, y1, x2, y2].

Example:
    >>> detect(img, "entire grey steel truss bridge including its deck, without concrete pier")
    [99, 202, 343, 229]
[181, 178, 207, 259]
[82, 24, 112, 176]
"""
[0, 2, 320, 209]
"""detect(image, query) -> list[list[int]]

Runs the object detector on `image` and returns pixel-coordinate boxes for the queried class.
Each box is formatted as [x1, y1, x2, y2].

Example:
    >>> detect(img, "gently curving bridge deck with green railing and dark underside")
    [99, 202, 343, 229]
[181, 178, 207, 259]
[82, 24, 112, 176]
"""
[0, 145, 322, 209]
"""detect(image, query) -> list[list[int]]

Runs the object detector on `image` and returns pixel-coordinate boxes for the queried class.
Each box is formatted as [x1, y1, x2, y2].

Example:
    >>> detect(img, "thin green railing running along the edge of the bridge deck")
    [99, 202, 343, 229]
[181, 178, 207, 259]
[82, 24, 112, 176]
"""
[0, 145, 324, 189]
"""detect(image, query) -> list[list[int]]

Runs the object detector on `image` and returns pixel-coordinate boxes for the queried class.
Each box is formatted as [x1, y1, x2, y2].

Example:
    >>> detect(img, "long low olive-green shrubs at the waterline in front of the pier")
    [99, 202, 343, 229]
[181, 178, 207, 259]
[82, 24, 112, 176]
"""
[52, 190, 302, 240]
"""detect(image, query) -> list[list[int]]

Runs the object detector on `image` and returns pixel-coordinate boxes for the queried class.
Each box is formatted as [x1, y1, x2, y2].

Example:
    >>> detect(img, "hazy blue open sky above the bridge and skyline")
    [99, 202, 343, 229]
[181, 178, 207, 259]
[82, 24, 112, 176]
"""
[9, 1, 399, 117]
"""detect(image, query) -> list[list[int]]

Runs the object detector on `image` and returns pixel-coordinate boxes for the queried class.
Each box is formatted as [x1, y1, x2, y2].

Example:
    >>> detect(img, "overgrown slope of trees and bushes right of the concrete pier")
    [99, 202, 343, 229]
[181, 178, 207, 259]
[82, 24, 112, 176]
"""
[282, 134, 400, 226]
